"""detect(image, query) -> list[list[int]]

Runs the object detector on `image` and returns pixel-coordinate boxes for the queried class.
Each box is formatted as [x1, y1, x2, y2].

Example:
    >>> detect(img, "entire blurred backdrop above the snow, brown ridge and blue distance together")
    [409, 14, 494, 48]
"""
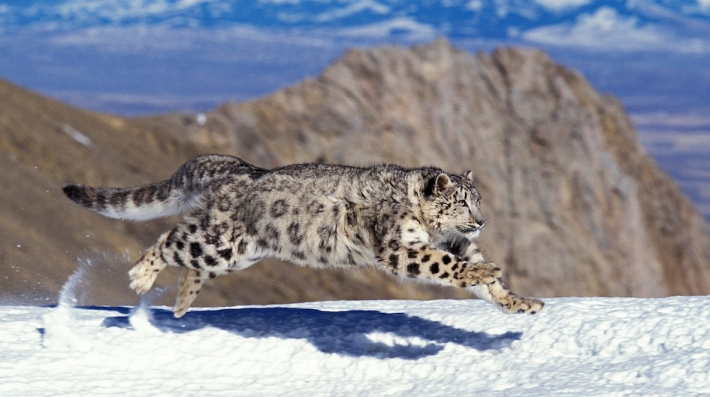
[0, 0, 710, 305]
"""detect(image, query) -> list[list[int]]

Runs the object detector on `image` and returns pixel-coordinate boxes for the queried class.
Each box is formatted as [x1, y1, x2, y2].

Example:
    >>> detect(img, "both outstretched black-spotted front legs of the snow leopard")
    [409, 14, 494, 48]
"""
[380, 242, 544, 314]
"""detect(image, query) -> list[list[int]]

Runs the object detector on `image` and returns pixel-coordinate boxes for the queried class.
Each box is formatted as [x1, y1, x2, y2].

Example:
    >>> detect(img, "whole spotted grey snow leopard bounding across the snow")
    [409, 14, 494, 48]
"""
[63, 155, 544, 317]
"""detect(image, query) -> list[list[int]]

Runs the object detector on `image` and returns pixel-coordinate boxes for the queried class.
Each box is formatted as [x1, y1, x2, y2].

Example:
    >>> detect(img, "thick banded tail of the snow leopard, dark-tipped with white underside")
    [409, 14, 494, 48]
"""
[62, 154, 260, 221]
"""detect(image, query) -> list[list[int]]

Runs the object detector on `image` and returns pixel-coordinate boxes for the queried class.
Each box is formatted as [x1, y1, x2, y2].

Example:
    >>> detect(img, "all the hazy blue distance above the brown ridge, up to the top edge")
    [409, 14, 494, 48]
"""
[0, 0, 710, 219]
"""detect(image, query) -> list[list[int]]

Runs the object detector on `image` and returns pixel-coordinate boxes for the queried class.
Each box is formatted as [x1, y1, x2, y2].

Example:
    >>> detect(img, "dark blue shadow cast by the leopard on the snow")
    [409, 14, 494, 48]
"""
[103, 307, 522, 359]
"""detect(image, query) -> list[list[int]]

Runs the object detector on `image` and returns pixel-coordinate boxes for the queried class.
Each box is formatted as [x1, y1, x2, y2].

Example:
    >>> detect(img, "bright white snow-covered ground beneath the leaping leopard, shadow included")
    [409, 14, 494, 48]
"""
[0, 297, 710, 396]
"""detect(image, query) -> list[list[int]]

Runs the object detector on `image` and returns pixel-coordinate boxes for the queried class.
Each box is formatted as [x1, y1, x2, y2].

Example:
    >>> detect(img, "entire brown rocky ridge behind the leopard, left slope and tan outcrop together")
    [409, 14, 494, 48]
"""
[0, 40, 710, 305]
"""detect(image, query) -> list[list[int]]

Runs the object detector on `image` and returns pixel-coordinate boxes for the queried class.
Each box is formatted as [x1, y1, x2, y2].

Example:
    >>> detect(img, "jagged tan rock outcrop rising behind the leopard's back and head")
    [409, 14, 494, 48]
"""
[199, 40, 710, 296]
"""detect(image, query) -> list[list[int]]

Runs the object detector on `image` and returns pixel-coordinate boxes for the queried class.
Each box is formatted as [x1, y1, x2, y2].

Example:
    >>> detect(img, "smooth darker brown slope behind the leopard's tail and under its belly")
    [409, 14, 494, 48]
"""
[0, 57, 466, 306]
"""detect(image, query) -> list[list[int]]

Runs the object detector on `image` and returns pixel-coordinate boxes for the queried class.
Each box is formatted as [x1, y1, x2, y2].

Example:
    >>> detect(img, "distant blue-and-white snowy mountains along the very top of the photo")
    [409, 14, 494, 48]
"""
[0, 0, 710, 52]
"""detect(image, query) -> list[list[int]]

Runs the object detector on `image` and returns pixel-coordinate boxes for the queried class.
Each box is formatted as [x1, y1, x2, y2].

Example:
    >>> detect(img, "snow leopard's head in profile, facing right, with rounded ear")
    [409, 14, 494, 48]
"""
[422, 171, 485, 240]
